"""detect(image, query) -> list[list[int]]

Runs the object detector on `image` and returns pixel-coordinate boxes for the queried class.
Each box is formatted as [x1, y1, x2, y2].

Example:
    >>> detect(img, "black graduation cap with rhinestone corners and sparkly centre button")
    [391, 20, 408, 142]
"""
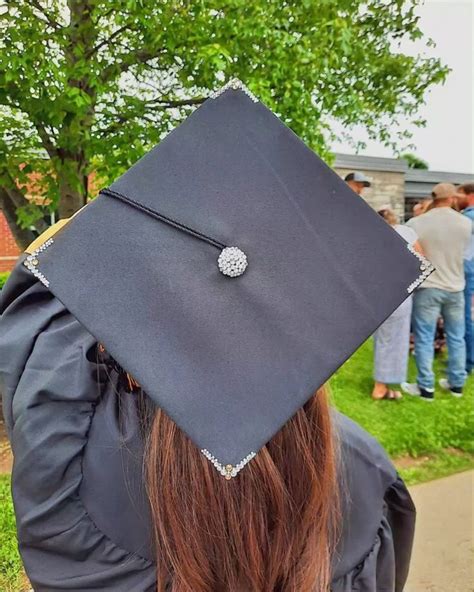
[25, 81, 432, 478]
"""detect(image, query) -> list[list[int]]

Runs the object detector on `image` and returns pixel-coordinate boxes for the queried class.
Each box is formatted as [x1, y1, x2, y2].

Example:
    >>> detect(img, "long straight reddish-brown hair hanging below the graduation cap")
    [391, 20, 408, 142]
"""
[145, 389, 338, 592]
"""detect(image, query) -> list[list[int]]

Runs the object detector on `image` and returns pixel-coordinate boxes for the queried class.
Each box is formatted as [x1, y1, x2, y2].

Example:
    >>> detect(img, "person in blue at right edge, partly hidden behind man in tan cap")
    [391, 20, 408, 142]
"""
[458, 183, 474, 373]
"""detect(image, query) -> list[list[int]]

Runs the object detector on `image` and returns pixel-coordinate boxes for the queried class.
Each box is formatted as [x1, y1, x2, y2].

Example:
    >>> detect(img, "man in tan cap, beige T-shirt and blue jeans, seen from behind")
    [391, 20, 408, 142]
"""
[401, 183, 472, 401]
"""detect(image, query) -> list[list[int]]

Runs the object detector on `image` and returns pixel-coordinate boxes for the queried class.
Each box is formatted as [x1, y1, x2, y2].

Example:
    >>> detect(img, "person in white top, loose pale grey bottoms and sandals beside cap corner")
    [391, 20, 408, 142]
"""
[372, 207, 423, 401]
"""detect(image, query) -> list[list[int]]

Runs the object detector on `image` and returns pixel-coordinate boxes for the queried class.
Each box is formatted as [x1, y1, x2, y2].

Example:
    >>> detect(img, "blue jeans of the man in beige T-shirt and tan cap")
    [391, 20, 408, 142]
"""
[413, 288, 467, 390]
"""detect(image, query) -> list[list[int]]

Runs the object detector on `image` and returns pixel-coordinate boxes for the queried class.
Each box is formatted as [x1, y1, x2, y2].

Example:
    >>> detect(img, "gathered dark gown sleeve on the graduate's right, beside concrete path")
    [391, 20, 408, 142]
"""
[331, 477, 416, 592]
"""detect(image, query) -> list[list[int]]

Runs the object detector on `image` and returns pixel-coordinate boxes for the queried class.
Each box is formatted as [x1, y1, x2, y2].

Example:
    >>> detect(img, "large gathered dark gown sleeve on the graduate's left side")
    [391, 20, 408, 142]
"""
[0, 264, 156, 592]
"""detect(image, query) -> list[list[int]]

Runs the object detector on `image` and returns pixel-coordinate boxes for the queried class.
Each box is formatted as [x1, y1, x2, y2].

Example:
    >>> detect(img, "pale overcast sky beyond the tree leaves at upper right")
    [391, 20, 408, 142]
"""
[333, 0, 474, 173]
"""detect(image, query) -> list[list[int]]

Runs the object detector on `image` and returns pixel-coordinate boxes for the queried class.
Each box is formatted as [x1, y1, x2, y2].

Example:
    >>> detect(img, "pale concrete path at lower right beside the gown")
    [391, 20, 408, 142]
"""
[405, 471, 474, 592]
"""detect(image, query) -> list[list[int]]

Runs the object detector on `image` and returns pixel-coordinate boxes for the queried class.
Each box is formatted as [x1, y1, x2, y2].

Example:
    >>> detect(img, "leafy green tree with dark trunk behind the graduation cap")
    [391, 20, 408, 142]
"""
[0, 0, 447, 246]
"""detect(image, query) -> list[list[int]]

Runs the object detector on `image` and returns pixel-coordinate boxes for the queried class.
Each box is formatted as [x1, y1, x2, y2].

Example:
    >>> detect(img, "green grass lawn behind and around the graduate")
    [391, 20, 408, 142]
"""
[0, 340, 474, 592]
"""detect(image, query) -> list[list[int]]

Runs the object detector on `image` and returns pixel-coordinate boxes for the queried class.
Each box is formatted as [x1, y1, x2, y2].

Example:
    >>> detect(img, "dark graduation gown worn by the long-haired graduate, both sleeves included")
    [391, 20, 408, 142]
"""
[0, 262, 415, 592]
